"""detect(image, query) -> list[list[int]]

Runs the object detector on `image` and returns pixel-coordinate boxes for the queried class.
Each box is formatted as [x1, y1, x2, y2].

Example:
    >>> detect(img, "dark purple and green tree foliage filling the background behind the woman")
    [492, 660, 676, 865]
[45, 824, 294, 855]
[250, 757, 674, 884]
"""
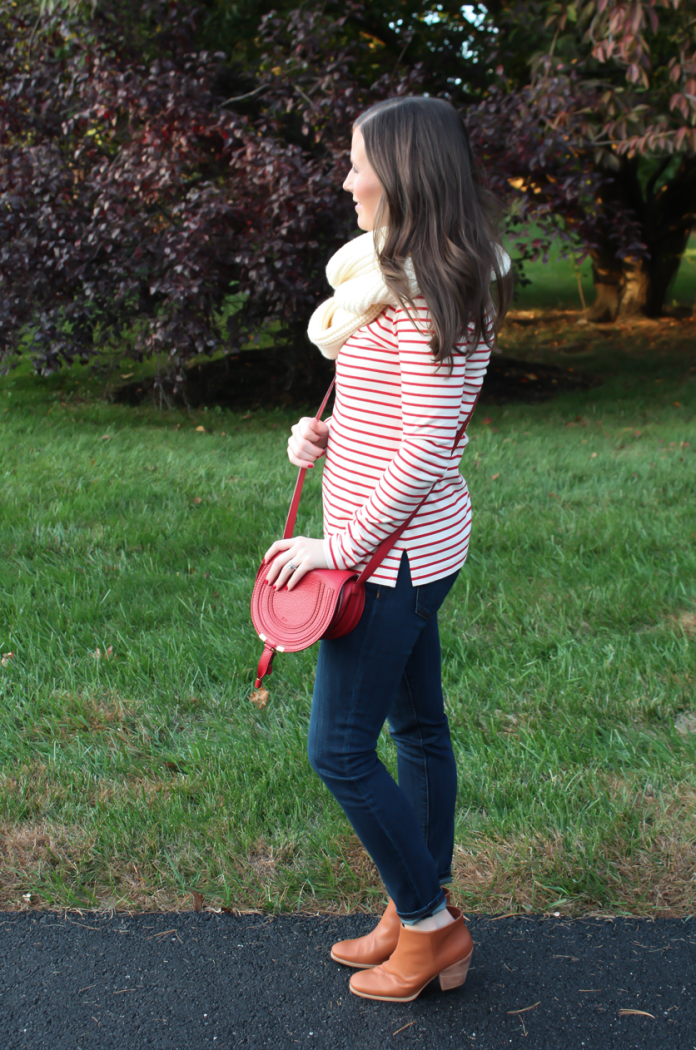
[0, 0, 696, 388]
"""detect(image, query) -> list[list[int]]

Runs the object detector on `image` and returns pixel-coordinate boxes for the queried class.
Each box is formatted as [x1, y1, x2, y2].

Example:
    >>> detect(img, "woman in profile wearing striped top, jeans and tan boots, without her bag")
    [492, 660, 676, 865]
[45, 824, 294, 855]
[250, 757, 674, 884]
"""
[266, 98, 509, 1002]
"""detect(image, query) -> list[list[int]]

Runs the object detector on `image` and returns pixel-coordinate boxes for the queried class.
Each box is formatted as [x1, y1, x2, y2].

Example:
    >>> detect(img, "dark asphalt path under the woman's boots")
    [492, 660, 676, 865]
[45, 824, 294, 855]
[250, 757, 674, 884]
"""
[0, 910, 696, 1050]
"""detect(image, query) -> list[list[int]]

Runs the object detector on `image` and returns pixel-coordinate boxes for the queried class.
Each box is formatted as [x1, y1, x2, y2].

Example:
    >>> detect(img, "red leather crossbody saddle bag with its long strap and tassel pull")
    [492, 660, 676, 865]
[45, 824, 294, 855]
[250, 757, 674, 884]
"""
[251, 379, 478, 689]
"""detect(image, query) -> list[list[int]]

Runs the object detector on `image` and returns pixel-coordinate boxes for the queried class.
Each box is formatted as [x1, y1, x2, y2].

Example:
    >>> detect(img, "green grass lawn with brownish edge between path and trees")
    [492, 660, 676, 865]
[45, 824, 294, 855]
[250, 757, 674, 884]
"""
[0, 308, 696, 915]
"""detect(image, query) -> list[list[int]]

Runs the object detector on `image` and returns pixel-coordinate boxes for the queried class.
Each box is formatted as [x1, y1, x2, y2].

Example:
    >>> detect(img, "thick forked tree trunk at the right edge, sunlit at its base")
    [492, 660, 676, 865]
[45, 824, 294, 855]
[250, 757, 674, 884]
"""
[588, 158, 696, 323]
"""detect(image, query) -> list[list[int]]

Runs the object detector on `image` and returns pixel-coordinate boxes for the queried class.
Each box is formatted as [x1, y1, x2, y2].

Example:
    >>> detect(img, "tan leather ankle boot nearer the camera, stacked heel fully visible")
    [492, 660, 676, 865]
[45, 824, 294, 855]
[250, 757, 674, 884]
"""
[351, 905, 473, 1003]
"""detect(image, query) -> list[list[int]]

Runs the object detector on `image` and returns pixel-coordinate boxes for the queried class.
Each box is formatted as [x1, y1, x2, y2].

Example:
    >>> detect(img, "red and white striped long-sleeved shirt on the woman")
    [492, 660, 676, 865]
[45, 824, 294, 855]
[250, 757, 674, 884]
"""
[322, 296, 490, 587]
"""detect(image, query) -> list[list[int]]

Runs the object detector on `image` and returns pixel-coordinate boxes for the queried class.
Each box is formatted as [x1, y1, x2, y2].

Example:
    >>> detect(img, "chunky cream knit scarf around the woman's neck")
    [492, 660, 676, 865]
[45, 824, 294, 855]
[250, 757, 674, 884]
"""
[307, 232, 418, 360]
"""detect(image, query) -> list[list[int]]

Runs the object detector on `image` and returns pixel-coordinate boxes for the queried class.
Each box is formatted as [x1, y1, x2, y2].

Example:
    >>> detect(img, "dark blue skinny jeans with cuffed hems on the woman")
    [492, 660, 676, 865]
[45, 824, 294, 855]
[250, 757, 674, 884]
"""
[308, 554, 458, 921]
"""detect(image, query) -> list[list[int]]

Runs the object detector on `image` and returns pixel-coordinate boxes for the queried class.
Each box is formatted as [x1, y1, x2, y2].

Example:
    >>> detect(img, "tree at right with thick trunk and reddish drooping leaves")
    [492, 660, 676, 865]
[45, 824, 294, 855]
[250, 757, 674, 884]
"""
[491, 0, 696, 320]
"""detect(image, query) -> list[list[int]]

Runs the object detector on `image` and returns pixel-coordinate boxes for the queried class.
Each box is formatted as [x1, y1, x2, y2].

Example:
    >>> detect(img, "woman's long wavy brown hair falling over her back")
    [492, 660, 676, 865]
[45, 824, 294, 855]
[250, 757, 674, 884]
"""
[354, 96, 512, 363]
